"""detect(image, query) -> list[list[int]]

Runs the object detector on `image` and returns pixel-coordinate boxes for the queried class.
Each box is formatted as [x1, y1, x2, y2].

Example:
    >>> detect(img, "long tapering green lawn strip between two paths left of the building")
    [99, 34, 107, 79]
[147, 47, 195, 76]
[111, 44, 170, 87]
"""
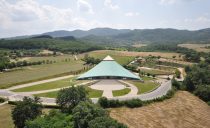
[12, 77, 79, 92]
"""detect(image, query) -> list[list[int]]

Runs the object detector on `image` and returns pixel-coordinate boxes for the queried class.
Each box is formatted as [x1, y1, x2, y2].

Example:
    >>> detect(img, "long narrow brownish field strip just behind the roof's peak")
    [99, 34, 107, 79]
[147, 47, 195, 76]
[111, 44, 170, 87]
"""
[90, 50, 180, 59]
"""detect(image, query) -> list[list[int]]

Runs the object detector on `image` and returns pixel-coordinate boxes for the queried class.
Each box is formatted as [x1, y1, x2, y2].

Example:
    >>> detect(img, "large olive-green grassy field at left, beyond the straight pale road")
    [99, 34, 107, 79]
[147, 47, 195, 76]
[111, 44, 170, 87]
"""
[0, 57, 84, 88]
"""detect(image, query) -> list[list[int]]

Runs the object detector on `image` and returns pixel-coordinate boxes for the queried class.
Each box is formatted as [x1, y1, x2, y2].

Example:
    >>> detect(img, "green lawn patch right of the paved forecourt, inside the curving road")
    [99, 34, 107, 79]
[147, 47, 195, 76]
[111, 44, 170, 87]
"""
[127, 80, 159, 94]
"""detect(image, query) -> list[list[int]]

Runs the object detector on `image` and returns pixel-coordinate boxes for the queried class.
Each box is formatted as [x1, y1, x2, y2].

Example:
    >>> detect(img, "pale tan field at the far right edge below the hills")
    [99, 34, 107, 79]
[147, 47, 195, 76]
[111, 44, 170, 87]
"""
[178, 44, 210, 52]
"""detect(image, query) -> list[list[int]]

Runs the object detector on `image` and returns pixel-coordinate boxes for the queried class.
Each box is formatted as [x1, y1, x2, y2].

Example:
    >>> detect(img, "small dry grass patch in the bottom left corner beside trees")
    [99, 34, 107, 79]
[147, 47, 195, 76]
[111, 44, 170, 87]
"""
[0, 104, 14, 128]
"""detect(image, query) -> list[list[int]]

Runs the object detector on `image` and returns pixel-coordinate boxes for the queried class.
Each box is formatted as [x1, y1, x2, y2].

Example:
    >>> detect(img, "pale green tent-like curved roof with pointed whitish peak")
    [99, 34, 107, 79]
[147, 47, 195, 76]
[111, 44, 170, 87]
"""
[77, 56, 140, 80]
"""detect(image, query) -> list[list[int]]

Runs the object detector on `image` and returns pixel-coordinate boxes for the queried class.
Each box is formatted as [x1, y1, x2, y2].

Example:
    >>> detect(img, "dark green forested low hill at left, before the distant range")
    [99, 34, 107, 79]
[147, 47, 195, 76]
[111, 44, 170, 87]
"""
[0, 36, 102, 53]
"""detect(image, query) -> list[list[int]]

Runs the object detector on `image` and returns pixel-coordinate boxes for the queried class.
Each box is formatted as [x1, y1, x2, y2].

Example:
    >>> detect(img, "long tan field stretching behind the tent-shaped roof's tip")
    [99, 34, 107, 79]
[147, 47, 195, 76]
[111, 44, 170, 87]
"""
[89, 50, 181, 61]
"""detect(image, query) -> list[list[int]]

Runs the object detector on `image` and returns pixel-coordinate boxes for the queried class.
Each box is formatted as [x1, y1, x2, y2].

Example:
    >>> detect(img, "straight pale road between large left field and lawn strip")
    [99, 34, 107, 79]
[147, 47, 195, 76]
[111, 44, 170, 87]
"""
[6, 75, 74, 90]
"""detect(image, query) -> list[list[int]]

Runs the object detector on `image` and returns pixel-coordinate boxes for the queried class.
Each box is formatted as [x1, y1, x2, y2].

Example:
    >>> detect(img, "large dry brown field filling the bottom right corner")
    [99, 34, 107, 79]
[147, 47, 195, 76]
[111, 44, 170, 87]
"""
[110, 91, 210, 128]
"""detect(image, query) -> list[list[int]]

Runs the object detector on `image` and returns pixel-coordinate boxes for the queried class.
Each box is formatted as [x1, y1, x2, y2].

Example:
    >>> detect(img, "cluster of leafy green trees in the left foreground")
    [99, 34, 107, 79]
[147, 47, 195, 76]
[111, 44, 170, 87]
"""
[12, 86, 127, 128]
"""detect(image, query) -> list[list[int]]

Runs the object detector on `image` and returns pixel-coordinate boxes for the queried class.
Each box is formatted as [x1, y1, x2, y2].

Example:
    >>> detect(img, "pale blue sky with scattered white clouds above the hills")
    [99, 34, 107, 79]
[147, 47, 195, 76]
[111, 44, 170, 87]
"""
[0, 0, 210, 38]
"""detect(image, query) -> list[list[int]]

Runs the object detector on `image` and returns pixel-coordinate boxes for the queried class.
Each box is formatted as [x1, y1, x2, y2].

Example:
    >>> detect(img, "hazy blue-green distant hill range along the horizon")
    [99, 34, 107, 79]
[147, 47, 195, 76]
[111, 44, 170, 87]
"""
[2, 28, 210, 45]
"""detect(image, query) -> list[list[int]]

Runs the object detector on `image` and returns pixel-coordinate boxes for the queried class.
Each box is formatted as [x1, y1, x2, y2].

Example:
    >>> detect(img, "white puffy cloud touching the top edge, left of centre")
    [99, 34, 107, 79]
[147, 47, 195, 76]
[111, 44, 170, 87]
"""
[77, 0, 93, 14]
